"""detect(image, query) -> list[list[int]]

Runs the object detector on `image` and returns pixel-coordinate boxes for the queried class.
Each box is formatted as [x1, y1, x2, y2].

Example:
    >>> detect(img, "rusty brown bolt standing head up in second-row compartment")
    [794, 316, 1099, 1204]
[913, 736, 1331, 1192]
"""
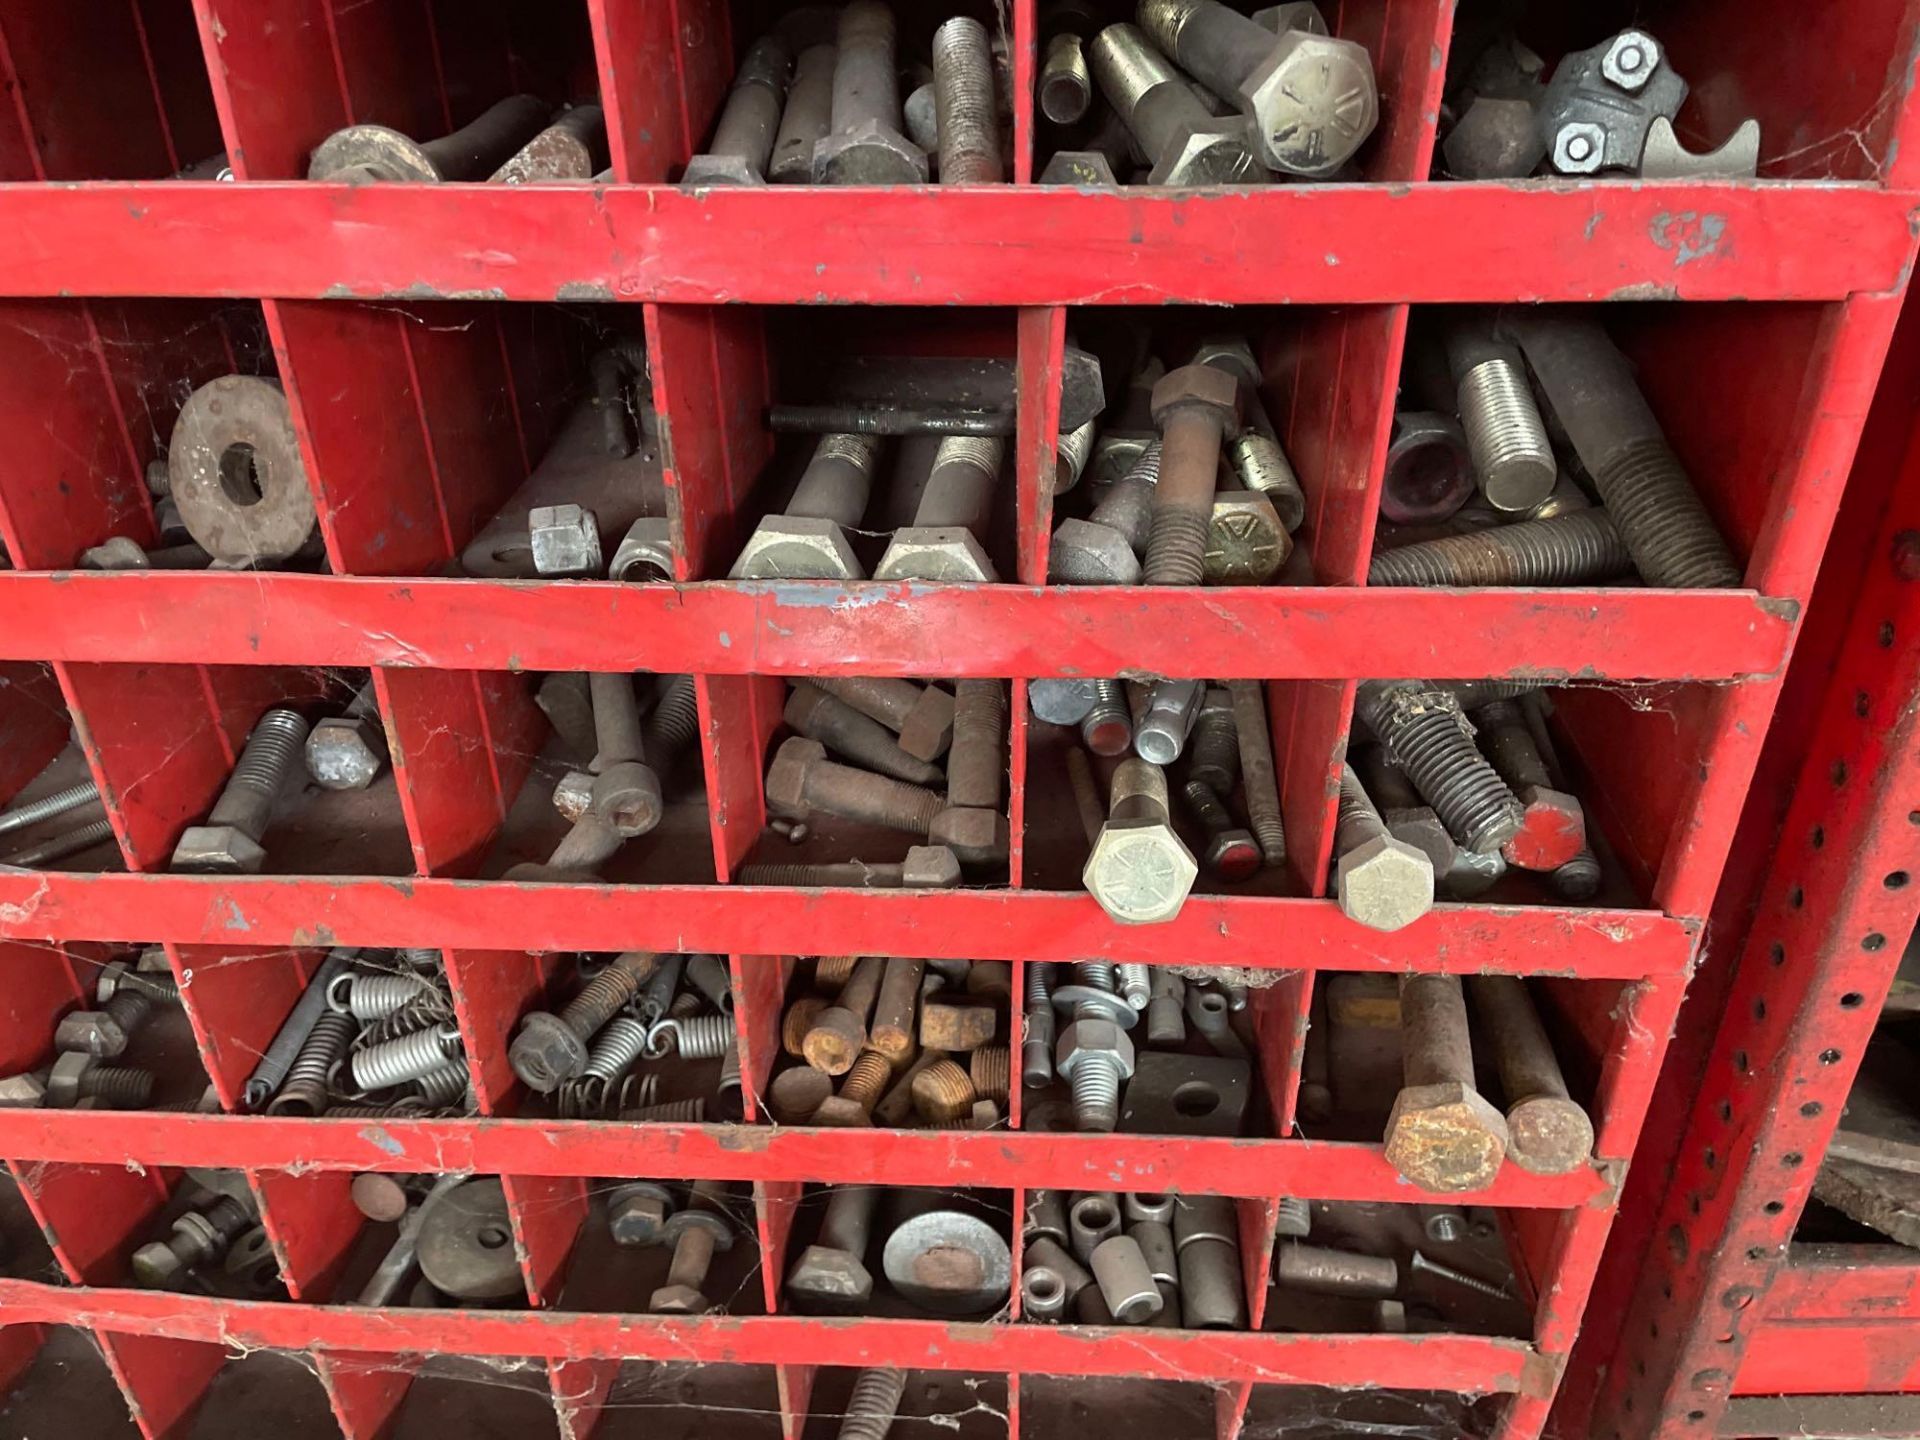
[1146, 365, 1240, 586]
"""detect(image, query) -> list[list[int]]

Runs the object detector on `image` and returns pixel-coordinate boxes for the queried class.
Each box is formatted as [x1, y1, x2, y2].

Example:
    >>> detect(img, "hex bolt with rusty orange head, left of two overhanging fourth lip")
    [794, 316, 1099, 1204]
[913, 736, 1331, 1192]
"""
[1386, 975, 1507, 1192]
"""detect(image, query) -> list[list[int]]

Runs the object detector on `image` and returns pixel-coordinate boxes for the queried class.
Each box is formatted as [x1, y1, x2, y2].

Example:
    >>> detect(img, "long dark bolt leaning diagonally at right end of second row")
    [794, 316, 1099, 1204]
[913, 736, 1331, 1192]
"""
[1505, 315, 1741, 589]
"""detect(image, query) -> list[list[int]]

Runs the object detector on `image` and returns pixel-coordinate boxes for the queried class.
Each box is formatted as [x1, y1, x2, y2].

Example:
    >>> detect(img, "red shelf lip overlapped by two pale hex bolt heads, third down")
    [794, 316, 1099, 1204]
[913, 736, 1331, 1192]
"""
[0, 870, 1699, 983]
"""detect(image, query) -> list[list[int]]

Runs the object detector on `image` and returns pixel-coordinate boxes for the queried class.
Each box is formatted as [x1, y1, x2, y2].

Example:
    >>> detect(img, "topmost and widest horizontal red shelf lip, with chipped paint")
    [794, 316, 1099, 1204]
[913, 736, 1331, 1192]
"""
[0, 180, 1914, 305]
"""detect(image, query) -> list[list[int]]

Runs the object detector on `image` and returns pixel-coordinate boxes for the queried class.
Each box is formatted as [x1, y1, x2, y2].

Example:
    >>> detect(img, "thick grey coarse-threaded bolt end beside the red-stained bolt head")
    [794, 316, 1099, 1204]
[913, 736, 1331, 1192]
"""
[1356, 680, 1523, 854]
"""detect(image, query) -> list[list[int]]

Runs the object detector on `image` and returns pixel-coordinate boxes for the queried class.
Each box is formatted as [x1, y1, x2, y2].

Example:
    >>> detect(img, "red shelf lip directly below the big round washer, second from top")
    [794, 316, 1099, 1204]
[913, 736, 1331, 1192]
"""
[0, 570, 1799, 684]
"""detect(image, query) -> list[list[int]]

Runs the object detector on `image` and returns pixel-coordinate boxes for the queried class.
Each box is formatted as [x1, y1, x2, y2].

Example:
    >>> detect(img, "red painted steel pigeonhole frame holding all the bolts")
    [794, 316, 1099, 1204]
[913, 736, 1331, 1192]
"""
[0, 0, 1920, 1440]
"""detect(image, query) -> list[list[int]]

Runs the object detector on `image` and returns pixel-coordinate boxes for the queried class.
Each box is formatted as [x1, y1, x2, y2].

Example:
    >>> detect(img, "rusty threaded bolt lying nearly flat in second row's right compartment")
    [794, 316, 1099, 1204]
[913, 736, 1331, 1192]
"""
[1367, 509, 1634, 586]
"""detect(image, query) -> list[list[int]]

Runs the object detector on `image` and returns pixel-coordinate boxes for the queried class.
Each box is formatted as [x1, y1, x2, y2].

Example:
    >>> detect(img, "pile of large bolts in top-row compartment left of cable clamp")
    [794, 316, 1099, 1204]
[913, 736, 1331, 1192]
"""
[1039, 0, 1380, 188]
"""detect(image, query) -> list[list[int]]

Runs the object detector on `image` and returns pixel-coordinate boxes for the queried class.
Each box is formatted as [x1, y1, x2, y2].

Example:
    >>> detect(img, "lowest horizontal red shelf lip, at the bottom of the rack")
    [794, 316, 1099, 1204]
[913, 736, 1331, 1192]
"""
[0, 1279, 1536, 1394]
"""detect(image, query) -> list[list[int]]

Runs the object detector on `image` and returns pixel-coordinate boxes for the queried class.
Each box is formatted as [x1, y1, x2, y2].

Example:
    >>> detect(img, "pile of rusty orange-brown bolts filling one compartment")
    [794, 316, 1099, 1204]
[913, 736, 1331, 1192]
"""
[766, 956, 1012, 1129]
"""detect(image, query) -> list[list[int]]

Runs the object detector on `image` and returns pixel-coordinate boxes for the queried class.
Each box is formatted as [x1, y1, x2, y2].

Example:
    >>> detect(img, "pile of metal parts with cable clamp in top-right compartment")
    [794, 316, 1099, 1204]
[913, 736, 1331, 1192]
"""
[1434, 29, 1761, 180]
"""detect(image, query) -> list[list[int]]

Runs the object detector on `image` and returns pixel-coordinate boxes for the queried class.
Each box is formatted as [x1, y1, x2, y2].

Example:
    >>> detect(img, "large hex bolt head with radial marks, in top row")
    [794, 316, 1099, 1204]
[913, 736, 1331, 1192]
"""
[1238, 31, 1380, 179]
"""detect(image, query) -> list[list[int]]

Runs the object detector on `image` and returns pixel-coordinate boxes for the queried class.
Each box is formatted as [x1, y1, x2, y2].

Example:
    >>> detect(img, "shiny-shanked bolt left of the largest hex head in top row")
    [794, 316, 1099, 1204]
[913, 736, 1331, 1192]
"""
[1087, 25, 1267, 186]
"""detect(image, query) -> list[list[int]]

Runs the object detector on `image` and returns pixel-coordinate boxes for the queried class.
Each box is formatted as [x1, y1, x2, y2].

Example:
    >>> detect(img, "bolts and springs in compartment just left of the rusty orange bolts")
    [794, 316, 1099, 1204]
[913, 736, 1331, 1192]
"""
[507, 950, 743, 1123]
